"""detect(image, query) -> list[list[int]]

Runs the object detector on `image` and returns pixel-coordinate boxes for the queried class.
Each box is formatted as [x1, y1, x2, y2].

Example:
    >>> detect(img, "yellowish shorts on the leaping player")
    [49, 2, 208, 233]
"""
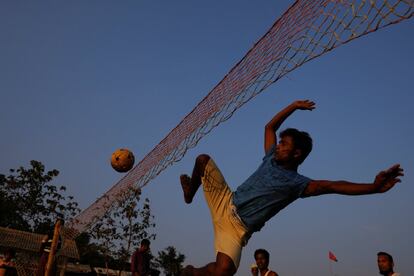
[201, 159, 249, 268]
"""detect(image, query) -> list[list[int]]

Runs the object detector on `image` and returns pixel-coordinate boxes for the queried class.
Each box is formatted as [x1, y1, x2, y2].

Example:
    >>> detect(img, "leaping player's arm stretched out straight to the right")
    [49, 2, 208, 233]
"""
[302, 164, 404, 197]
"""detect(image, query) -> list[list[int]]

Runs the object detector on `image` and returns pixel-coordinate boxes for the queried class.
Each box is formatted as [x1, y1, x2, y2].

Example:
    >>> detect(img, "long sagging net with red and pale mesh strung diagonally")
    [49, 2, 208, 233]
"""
[68, 0, 414, 235]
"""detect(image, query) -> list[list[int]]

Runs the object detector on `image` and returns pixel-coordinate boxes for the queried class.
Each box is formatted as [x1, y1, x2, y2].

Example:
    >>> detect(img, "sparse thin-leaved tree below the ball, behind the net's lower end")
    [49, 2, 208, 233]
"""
[90, 187, 155, 269]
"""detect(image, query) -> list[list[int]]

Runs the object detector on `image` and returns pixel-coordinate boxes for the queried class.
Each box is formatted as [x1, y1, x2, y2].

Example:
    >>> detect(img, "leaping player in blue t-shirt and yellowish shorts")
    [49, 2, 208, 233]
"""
[180, 100, 403, 276]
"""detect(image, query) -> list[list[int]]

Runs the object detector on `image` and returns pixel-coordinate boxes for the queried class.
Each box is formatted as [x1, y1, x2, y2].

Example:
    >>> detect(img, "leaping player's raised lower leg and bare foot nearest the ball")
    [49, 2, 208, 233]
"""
[180, 154, 210, 204]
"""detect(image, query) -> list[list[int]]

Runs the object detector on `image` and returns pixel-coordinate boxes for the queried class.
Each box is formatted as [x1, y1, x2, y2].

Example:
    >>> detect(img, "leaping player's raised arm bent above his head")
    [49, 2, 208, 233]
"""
[264, 100, 315, 153]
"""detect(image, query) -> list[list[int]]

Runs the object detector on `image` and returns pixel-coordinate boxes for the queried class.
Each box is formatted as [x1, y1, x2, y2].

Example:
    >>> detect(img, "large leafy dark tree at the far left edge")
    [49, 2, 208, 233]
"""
[0, 160, 80, 233]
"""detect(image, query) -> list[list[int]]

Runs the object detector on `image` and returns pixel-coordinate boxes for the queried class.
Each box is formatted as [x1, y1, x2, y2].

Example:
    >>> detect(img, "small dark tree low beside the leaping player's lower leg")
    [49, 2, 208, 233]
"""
[155, 246, 185, 276]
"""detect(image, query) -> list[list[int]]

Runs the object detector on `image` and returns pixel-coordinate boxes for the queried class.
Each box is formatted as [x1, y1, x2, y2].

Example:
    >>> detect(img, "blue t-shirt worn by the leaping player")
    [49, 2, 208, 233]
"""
[233, 146, 311, 233]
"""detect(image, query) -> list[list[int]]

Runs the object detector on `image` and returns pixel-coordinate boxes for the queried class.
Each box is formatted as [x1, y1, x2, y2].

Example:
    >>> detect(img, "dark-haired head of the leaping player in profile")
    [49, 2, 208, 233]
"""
[276, 128, 312, 167]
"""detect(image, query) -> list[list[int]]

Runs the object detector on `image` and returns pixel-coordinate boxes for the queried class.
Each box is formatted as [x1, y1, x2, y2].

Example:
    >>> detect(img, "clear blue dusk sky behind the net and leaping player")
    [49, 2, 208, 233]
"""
[0, 0, 414, 276]
